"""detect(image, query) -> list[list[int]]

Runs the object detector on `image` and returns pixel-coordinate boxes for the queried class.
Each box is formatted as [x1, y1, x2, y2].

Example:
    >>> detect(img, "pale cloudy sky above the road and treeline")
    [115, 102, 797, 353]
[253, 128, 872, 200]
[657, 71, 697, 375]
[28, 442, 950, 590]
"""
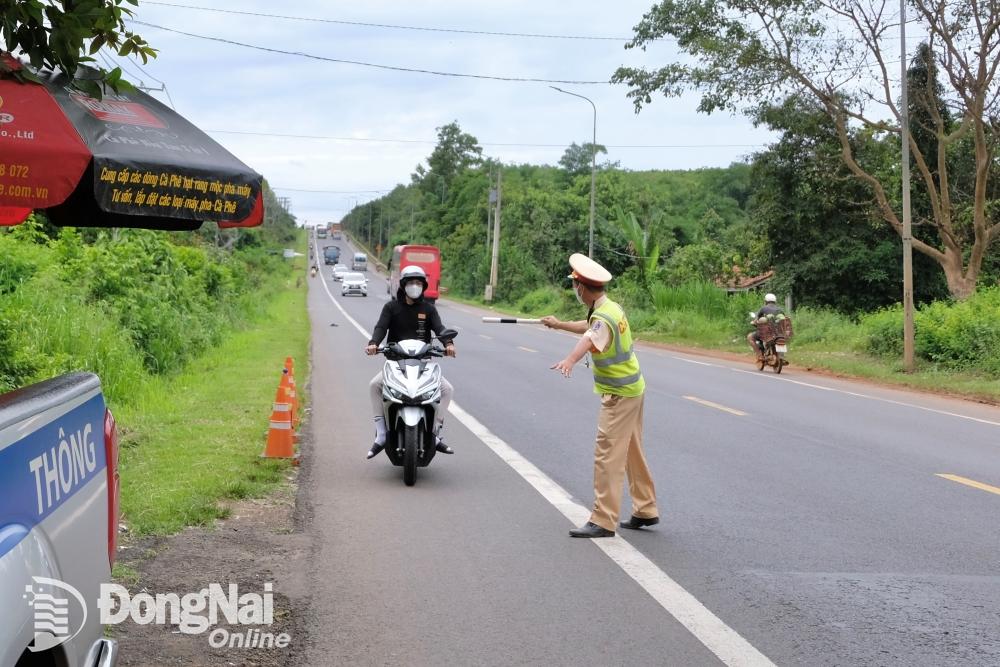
[117, 0, 774, 224]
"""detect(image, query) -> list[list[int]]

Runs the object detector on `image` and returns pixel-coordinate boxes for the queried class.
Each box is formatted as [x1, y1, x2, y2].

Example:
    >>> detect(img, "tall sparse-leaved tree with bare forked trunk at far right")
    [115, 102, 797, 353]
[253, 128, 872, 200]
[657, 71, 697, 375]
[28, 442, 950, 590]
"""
[612, 0, 1000, 298]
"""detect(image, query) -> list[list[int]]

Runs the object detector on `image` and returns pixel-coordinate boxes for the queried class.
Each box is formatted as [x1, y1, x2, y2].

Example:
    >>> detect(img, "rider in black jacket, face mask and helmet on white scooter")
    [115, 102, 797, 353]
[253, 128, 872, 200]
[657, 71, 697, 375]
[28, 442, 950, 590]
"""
[365, 265, 455, 459]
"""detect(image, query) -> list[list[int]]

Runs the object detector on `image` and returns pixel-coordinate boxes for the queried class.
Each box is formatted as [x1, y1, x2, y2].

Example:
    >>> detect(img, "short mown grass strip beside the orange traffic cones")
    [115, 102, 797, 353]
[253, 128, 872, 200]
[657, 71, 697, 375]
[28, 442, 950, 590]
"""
[115, 262, 309, 535]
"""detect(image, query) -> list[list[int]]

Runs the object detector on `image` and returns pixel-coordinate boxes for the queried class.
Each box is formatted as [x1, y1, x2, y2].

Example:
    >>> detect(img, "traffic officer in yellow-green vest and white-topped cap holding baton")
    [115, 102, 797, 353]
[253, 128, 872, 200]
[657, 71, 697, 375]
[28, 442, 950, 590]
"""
[542, 253, 660, 537]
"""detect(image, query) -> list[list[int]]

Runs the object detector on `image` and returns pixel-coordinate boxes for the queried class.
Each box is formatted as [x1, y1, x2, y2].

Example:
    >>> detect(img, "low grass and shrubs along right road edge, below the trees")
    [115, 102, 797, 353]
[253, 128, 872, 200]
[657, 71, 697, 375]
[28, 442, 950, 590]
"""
[474, 283, 1000, 403]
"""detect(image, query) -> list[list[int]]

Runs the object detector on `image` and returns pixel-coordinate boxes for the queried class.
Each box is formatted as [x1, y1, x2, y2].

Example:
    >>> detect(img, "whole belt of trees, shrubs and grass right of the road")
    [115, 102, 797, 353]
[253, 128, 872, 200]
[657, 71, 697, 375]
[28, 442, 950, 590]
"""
[345, 117, 1000, 402]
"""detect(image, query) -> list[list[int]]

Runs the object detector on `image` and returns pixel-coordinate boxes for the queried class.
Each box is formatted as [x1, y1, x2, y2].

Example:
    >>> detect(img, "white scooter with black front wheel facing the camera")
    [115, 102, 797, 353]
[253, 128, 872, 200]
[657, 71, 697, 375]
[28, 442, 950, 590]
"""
[378, 329, 458, 486]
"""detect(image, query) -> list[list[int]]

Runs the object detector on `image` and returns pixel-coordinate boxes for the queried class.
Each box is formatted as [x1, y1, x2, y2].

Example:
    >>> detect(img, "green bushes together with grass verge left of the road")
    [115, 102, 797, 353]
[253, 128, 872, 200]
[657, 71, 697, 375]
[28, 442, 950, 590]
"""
[0, 184, 309, 534]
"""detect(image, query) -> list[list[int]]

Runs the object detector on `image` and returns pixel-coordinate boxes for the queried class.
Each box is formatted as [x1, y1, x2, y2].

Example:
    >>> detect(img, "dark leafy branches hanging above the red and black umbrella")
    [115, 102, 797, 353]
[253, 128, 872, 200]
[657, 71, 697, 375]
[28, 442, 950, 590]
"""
[0, 0, 156, 97]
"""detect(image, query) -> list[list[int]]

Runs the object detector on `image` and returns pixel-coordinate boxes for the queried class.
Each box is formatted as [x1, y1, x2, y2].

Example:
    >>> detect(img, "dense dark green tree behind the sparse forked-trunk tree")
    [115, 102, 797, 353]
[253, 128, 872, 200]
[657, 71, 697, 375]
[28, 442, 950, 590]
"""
[751, 99, 947, 314]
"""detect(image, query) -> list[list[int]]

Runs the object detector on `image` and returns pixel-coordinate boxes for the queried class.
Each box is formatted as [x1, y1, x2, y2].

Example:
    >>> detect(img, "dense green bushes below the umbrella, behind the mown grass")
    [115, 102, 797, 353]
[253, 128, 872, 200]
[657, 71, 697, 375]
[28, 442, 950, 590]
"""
[0, 223, 302, 401]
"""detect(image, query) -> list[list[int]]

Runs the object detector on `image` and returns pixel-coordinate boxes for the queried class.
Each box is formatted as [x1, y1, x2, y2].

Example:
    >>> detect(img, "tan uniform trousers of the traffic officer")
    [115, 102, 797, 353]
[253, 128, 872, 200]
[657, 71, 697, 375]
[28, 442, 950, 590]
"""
[590, 394, 659, 530]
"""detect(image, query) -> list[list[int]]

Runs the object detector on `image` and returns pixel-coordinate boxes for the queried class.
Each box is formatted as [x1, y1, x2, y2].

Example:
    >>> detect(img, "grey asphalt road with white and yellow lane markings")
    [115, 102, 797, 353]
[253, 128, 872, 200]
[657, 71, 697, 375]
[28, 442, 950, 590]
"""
[303, 240, 1000, 665]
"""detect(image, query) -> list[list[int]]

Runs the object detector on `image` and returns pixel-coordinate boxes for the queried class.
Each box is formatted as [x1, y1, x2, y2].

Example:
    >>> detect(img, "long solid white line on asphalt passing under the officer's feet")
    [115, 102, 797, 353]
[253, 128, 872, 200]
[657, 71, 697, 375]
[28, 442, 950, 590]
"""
[323, 282, 774, 667]
